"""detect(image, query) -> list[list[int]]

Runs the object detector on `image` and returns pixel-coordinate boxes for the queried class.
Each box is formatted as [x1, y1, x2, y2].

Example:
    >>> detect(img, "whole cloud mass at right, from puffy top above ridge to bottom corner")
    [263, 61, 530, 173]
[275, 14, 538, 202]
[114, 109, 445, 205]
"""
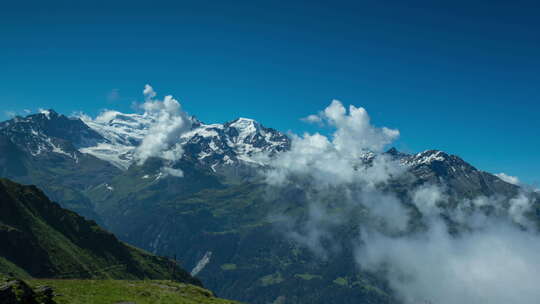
[265, 100, 540, 304]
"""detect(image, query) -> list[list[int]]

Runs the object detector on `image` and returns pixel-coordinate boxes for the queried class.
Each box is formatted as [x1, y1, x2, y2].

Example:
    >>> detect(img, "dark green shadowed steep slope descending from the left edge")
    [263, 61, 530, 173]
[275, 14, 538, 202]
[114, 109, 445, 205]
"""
[0, 179, 200, 284]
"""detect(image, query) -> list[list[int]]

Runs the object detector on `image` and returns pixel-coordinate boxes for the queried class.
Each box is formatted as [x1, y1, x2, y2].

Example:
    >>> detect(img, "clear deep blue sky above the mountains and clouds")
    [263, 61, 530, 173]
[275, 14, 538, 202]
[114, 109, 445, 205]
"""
[0, 1, 540, 185]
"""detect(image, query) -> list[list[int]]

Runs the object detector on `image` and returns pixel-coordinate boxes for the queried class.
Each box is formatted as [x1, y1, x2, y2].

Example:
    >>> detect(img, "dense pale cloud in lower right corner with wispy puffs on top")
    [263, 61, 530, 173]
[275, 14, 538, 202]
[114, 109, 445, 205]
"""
[356, 180, 540, 304]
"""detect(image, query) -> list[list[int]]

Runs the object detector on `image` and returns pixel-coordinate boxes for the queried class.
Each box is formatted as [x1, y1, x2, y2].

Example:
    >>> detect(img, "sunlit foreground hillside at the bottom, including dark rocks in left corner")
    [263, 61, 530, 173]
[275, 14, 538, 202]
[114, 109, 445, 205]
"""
[0, 275, 237, 304]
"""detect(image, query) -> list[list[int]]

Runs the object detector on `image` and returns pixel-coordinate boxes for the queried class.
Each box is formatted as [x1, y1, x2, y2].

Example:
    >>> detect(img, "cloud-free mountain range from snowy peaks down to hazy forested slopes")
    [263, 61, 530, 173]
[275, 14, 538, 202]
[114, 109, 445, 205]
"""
[0, 111, 540, 304]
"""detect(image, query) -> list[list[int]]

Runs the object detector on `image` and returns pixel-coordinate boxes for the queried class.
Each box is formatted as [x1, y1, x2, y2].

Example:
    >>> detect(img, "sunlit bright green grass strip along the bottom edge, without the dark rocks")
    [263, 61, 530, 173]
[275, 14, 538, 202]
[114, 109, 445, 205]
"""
[28, 279, 238, 304]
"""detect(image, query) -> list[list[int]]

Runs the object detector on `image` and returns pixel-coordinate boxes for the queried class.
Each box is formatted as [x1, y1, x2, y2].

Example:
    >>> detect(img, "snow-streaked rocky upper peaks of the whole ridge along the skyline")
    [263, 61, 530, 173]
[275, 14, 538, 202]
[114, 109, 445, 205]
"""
[0, 110, 520, 189]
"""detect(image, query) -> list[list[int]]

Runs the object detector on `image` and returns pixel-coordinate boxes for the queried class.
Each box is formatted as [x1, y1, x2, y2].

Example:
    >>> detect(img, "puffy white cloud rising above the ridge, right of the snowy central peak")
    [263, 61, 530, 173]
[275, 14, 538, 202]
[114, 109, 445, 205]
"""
[266, 100, 402, 185]
